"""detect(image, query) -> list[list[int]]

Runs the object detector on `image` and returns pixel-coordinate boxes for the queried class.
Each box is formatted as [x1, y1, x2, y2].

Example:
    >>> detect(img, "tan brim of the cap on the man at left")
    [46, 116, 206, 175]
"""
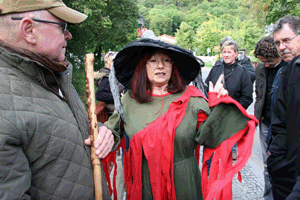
[47, 6, 87, 24]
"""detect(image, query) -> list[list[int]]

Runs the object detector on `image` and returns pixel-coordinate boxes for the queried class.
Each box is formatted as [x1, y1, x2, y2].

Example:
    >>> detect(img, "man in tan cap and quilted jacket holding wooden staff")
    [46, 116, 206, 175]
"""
[0, 0, 120, 200]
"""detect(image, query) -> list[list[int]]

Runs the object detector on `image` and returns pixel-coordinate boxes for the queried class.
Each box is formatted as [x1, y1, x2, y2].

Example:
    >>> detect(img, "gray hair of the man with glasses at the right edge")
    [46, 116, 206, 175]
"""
[273, 15, 300, 35]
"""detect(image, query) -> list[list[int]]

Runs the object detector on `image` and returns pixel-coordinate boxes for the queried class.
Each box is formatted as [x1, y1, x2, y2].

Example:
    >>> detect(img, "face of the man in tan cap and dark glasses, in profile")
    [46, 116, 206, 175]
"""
[34, 12, 72, 61]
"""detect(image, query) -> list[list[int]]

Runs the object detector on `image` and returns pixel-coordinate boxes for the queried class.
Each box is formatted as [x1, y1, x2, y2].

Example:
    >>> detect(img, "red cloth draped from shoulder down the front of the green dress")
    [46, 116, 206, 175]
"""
[126, 87, 204, 200]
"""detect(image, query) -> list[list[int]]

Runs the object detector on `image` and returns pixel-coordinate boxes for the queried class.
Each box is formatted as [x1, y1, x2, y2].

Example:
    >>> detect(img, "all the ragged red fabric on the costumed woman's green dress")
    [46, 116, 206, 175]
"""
[103, 86, 257, 200]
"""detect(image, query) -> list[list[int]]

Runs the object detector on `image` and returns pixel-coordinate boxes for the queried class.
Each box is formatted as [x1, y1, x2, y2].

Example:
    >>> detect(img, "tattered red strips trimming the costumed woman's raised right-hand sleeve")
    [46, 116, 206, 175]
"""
[202, 93, 258, 200]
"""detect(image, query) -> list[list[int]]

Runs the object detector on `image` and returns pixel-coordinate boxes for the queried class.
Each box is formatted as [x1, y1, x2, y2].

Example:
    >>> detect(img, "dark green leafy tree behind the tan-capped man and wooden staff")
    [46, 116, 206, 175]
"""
[64, 0, 138, 102]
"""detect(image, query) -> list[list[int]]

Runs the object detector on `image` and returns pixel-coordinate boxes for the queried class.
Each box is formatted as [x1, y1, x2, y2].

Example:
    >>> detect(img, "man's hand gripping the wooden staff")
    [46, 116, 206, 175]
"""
[84, 126, 115, 159]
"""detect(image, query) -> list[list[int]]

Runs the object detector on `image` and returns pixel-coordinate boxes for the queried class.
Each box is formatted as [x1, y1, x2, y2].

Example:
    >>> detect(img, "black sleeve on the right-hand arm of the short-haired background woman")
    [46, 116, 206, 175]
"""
[239, 70, 253, 109]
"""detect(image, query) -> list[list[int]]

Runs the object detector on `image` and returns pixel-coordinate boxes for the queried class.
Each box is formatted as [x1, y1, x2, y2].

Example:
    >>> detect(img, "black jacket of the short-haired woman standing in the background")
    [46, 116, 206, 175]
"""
[205, 62, 253, 109]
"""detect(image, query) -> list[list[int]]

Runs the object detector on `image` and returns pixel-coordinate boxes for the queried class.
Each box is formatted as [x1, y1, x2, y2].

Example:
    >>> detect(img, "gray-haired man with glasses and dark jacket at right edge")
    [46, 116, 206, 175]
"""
[267, 16, 300, 200]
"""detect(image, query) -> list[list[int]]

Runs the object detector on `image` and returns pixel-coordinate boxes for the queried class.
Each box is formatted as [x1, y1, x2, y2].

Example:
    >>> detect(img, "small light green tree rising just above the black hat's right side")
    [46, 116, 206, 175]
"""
[175, 22, 195, 50]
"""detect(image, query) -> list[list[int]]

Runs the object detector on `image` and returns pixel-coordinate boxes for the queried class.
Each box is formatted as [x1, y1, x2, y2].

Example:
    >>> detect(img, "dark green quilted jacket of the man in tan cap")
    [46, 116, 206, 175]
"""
[0, 44, 119, 200]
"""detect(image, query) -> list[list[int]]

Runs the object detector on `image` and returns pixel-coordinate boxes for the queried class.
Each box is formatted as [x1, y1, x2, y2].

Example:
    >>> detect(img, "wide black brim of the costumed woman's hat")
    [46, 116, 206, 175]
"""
[114, 39, 204, 88]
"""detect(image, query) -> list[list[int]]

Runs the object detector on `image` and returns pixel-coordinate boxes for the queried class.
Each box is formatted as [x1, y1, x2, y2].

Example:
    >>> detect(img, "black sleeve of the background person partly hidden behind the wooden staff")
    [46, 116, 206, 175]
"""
[96, 77, 114, 104]
